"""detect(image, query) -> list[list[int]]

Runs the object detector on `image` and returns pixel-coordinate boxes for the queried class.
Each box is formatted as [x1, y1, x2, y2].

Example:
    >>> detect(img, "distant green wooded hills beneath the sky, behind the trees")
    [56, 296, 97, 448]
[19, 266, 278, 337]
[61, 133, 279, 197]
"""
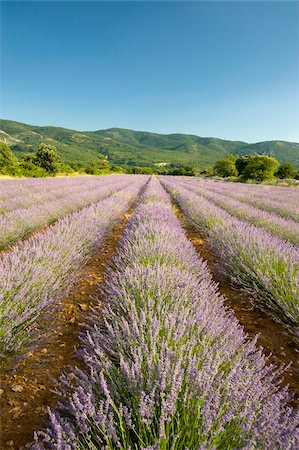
[0, 120, 299, 167]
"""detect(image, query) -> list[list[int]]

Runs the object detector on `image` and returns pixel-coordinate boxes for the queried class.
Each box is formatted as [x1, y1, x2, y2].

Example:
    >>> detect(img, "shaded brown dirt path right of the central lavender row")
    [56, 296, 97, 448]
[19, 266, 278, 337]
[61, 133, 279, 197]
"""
[175, 204, 299, 407]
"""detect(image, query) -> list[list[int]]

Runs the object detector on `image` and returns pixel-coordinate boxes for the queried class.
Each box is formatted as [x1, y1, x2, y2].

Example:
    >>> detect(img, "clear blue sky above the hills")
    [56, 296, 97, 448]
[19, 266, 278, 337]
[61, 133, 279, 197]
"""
[1, 1, 299, 142]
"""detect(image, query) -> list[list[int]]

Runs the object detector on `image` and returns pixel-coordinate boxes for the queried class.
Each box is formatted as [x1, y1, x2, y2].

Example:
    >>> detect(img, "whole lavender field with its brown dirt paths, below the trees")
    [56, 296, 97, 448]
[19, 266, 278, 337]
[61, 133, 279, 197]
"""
[0, 175, 299, 450]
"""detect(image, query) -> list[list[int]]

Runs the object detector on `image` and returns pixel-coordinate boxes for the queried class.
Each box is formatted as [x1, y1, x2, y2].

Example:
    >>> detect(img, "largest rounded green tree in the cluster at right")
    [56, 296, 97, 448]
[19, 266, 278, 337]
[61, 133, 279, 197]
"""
[242, 155, 279, 181]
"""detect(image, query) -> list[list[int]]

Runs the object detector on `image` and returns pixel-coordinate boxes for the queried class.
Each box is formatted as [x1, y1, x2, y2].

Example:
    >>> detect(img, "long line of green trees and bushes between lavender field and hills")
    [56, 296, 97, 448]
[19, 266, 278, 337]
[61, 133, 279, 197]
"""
[0, 141, 299, 182]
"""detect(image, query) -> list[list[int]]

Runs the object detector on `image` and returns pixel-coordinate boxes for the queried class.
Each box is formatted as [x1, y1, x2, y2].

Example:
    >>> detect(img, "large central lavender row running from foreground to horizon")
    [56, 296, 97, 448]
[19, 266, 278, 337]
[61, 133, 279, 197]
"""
[33, 179, 299, 450]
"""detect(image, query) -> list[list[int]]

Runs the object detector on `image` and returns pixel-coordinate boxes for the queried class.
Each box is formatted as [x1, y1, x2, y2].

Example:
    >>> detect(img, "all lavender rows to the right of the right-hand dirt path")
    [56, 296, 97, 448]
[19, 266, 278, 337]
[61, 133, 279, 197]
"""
[162, 178, 299, 334]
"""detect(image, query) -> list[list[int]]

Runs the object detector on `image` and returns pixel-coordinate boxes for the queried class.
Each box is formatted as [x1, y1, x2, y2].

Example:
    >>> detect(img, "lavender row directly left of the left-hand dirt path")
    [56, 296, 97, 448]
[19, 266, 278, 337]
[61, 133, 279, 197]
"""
[0, 177, 147, 353]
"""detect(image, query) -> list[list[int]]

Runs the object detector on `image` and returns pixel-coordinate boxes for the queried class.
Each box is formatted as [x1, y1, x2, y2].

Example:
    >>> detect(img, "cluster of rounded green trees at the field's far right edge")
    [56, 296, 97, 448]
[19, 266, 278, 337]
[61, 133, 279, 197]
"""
[213, 154, 299, 181]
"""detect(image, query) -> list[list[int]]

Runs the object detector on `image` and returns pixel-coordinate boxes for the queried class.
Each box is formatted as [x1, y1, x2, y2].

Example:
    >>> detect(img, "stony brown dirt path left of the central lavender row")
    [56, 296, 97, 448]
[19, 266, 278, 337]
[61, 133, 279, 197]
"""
[0, 204, 136, 450]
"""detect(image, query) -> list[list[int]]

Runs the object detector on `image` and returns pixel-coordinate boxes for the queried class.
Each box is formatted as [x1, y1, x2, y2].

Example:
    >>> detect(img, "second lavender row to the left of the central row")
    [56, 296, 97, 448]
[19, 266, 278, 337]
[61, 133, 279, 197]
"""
[0, 175, 136, 250]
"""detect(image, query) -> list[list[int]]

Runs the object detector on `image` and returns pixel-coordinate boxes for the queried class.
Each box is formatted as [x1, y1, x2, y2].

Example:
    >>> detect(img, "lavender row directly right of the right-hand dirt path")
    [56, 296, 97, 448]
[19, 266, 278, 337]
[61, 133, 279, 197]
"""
[162, 177, 299, 333]
